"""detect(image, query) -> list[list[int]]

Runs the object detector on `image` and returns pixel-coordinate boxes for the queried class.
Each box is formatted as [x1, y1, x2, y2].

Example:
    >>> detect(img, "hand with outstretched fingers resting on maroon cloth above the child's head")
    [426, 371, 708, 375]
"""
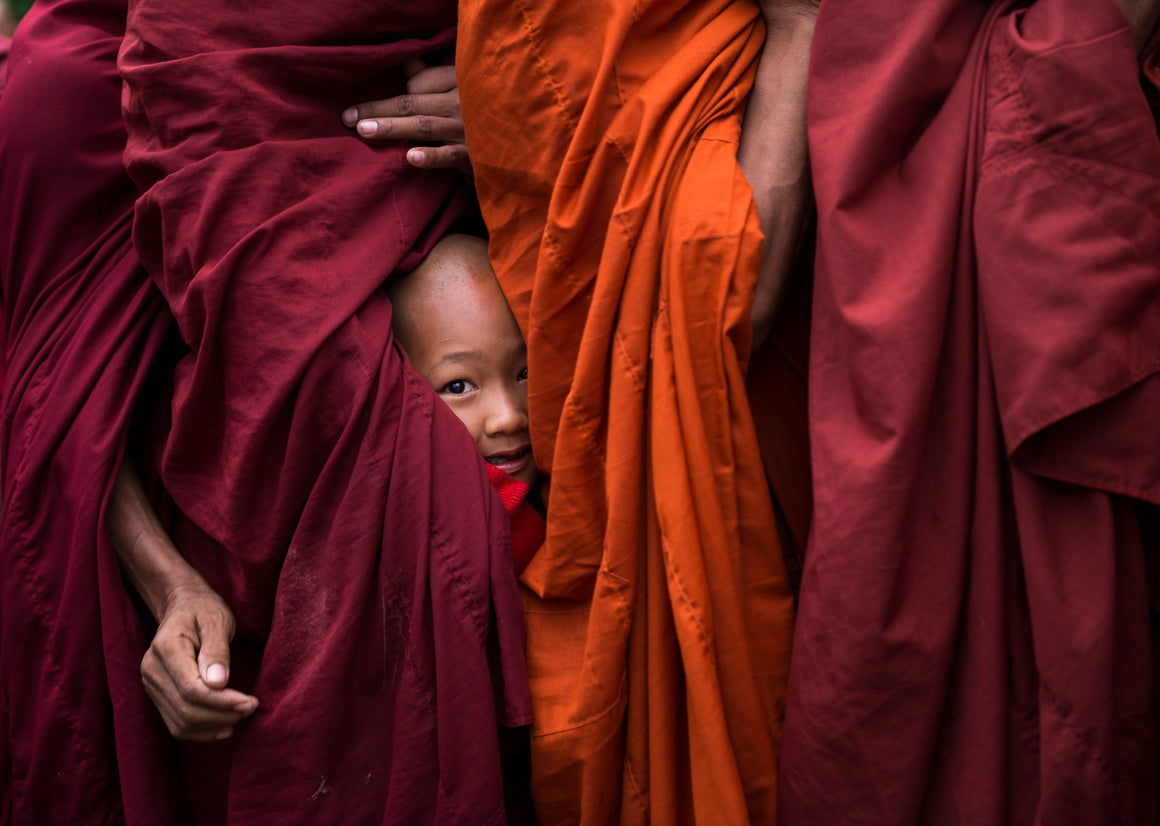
[342, 60, 471, 175]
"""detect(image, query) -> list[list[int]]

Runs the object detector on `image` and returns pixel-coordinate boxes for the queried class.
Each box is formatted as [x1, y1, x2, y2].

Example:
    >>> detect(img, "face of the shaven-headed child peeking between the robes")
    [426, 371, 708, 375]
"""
[400, 265, 537, 484]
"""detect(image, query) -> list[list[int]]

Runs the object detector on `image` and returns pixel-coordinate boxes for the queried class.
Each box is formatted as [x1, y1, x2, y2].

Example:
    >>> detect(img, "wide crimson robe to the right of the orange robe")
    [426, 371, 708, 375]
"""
[780, 0, 1160, 826]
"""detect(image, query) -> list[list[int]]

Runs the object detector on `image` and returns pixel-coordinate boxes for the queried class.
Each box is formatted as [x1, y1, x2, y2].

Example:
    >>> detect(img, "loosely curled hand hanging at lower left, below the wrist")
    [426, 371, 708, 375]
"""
[142, 578, 258, 742]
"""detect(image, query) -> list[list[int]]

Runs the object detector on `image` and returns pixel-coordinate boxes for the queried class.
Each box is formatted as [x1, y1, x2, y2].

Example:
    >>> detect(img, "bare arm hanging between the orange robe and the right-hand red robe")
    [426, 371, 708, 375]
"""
[738, 3, 815, 347]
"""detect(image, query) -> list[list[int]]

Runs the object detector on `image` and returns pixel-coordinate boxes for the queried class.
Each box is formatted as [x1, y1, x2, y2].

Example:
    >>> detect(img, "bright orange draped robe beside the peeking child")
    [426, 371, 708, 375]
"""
[457, 0, 806, 825]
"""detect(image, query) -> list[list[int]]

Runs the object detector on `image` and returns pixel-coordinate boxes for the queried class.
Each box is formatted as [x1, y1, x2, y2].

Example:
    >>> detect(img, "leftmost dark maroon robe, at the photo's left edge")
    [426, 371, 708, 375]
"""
[0, 0, 181, 824]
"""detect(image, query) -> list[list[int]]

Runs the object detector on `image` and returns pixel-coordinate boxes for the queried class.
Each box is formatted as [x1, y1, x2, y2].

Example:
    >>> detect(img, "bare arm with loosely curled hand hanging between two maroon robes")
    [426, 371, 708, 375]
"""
[108, 457, 258, 741]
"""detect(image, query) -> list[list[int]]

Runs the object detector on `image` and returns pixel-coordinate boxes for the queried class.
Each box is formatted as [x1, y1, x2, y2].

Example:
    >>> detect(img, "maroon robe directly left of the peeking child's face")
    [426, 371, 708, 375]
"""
[119, 0, 530, 824]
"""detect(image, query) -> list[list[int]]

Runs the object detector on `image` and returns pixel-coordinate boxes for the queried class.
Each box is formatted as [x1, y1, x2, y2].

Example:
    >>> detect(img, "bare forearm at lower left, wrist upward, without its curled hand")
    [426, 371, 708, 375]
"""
[108, 457, 204, 621]
